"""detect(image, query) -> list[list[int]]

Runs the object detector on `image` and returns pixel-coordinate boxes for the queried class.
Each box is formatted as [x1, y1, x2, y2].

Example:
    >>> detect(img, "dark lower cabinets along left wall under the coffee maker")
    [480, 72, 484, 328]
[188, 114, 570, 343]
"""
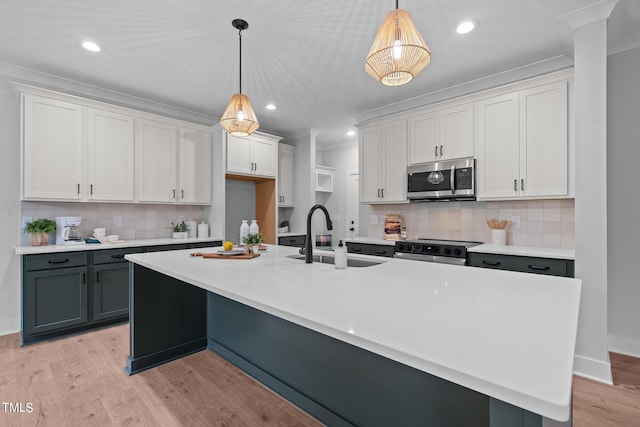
[21, 240, 222, 344]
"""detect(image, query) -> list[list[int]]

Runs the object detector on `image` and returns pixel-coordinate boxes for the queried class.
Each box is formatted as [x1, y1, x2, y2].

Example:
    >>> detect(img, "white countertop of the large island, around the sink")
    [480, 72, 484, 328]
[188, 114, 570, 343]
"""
[126, 245, 581, 421]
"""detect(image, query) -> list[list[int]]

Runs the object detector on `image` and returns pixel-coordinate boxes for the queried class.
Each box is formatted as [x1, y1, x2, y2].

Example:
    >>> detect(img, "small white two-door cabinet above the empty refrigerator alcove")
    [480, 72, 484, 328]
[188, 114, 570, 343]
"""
[227, 133, 279, 178]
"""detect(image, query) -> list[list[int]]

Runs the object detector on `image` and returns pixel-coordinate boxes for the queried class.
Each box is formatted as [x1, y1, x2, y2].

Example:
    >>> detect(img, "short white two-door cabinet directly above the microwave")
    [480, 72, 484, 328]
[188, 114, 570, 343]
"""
[408, 103, 474, 164]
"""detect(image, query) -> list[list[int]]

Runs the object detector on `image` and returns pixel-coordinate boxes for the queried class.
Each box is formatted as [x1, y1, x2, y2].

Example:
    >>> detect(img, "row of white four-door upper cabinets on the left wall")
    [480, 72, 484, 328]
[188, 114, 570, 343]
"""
[22, 91, 212, 205]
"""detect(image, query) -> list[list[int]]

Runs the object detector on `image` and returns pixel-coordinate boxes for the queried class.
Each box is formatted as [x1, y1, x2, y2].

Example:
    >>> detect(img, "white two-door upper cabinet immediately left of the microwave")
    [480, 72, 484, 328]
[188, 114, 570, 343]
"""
[358, 119, 407, 203]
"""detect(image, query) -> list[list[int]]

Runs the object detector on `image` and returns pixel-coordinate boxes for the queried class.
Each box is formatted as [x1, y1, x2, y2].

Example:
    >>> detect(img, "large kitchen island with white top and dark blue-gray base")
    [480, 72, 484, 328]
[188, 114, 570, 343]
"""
[126, 246, 580, 426]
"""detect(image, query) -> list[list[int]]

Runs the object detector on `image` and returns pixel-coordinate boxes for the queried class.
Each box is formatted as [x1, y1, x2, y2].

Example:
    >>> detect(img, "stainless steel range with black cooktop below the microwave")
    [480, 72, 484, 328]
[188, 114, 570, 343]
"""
[393, 238, 481, 265]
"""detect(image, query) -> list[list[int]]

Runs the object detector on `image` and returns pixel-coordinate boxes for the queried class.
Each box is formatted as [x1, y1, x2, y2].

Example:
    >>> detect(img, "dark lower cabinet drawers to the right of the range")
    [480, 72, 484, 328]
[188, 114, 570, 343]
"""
[467, 252, 574, 277]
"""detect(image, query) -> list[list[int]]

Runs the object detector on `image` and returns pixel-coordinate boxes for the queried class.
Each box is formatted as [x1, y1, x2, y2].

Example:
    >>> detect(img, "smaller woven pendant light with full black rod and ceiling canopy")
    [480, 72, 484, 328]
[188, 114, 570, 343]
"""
[220, 19, 260, 136]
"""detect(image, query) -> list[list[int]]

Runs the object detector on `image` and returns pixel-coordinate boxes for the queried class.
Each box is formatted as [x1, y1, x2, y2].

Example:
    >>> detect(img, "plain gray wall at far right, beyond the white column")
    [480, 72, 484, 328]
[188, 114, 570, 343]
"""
[604, 49, 640, 357]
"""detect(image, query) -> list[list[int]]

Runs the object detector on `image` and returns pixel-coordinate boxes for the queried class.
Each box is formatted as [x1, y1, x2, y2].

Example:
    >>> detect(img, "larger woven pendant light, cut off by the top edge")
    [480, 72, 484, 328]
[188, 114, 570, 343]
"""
[364, 0, 431, 86]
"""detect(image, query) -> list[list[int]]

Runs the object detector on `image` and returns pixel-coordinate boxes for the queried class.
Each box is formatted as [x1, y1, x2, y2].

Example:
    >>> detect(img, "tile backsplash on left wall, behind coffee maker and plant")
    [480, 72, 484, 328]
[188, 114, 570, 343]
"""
[20, 202, 204, 245]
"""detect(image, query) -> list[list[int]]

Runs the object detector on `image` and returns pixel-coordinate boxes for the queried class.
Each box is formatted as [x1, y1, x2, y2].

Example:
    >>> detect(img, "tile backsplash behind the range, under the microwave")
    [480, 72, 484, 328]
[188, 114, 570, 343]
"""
[363, 199, 575, 249]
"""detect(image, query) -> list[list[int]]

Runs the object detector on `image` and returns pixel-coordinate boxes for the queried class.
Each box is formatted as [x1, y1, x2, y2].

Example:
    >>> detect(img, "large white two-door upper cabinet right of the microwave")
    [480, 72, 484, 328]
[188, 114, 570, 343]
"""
[476, 81, 569, 200]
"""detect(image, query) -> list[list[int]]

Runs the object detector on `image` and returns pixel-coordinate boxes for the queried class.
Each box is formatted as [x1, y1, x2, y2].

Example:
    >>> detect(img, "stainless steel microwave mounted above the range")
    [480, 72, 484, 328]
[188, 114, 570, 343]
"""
[407, 157, 476, 201]
